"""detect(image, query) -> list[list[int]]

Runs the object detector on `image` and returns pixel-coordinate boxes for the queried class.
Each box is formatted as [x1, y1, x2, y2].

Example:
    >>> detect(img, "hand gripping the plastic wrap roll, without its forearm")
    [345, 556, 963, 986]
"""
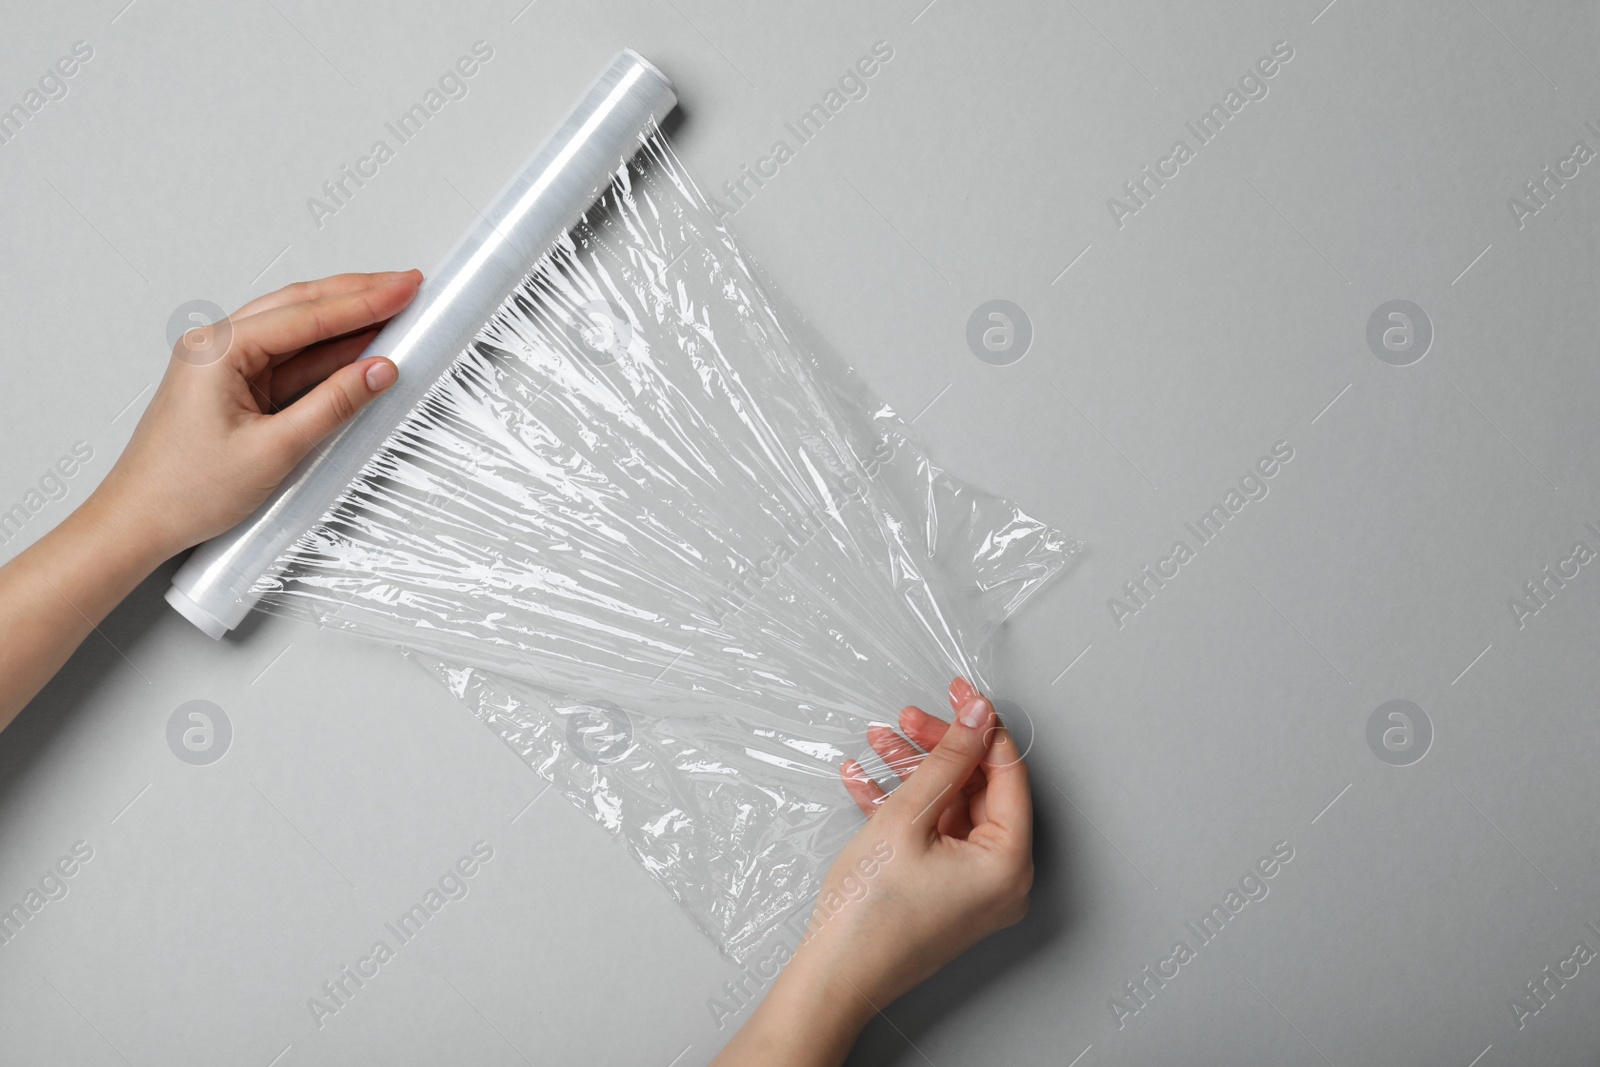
[94, 270, 422, 560]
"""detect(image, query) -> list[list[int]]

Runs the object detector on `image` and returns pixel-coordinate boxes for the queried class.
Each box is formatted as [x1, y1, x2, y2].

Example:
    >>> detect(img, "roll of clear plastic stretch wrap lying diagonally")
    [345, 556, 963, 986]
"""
[166, 50, 677, 638]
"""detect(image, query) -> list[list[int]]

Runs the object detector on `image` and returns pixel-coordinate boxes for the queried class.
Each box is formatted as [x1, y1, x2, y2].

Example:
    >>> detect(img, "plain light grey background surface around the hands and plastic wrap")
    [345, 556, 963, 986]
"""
[0, 0, 1600, 1067]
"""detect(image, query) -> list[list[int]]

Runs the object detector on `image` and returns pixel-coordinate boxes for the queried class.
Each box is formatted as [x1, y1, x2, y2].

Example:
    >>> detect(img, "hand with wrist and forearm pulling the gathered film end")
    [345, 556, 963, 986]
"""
[715, 678, 1034, 1067]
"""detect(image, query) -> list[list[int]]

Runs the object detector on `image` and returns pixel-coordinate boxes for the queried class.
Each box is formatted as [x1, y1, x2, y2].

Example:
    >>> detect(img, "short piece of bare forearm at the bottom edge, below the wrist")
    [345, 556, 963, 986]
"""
[712, 945, 874, 1067]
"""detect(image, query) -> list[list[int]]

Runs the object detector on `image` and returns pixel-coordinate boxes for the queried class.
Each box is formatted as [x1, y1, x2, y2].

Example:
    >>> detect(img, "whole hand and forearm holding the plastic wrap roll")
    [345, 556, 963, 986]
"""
[0, 270, 422, 729]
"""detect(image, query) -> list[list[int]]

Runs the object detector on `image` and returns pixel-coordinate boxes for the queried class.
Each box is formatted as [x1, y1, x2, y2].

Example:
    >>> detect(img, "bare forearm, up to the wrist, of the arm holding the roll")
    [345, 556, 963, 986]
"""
[0, 493, 165, 729]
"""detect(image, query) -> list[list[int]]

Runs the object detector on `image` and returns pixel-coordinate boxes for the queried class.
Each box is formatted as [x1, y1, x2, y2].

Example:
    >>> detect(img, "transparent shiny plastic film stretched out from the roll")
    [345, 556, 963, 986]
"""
[253, 131, 1078, 960]
